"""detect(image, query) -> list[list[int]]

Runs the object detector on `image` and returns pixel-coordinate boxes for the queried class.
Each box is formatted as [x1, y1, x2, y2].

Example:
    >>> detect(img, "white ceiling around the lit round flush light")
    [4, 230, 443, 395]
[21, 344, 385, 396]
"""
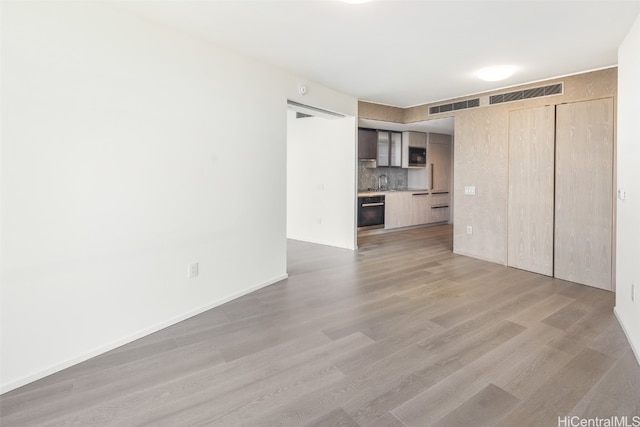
[120, 0, 640, 107]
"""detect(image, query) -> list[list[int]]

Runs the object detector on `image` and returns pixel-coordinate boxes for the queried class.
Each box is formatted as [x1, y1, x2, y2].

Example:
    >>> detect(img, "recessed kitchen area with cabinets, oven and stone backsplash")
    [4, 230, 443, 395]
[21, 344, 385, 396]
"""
[357, 119, 453, 235]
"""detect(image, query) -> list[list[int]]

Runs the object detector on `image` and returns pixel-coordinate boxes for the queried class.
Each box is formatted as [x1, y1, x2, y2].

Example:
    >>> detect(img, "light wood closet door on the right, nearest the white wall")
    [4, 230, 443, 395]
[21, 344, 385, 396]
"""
[554, 98, 613, 290]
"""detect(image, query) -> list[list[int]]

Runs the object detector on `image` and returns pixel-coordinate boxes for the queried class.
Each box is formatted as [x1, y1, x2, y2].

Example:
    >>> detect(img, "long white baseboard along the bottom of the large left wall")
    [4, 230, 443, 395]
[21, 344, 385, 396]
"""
[0, 274, 289, 394]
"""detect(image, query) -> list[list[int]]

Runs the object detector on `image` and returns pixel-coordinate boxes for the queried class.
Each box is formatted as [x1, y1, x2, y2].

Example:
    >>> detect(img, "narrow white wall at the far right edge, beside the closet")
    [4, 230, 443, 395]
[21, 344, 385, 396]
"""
[615, 16, 640, 362]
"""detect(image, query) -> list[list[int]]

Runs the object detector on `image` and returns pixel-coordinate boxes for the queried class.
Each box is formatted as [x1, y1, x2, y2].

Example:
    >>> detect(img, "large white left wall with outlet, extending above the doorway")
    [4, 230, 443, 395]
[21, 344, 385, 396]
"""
[0, 2, 357, 392]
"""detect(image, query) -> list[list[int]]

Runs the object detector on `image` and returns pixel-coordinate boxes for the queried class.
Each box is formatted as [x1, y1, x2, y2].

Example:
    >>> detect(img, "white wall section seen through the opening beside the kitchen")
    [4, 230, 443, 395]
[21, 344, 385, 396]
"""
[287, 111, 356, 249]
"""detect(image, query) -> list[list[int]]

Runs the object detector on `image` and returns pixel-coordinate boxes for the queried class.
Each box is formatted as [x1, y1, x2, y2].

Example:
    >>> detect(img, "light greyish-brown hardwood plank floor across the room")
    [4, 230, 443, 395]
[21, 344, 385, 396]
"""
[0, 226, 640, 427]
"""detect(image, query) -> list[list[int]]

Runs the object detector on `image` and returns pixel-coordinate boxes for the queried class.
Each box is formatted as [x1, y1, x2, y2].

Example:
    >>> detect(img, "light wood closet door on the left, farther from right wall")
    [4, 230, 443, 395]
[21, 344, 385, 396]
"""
[507, 106, 555, 276]
